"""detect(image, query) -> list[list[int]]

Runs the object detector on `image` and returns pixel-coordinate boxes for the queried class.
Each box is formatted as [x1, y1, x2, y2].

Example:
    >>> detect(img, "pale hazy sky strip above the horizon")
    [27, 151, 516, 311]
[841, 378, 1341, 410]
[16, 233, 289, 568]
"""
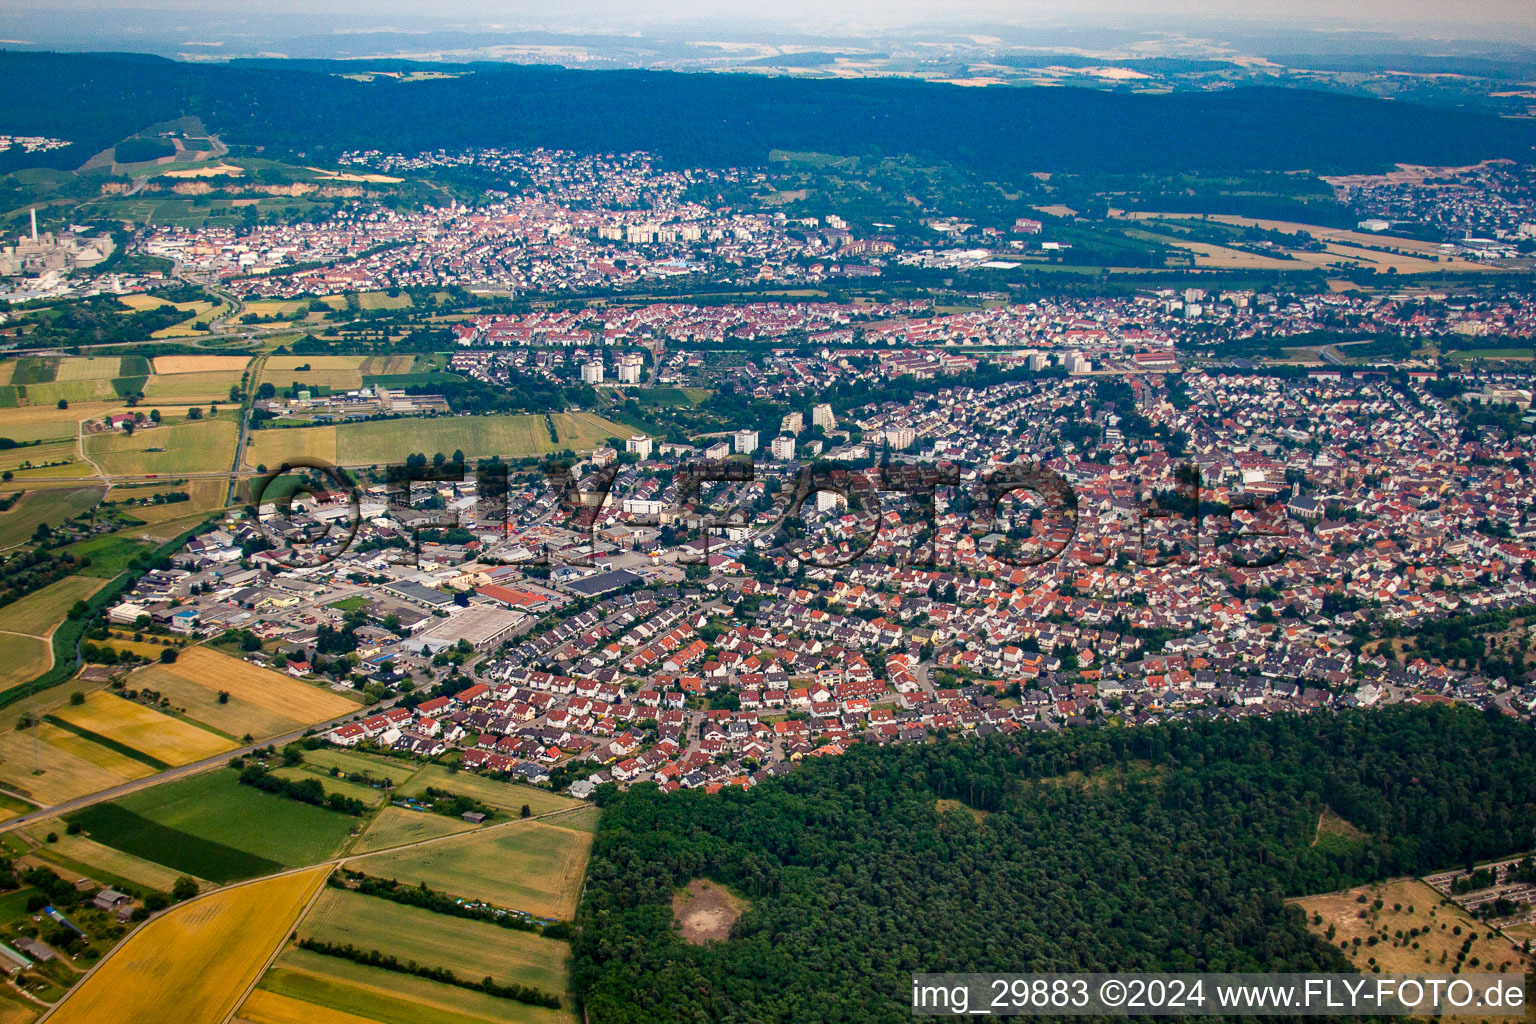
[0, 0, 1536, 40]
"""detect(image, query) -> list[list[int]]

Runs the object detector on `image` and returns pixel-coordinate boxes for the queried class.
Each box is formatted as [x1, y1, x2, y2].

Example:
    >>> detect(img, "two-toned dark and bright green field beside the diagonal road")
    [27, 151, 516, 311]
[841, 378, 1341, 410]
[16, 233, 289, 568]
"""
[66, 769, 361, 881]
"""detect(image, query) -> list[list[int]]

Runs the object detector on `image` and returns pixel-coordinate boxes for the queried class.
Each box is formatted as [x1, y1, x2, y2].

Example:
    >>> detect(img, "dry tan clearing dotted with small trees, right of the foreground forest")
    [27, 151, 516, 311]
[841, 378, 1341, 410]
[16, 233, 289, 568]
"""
[1293, 878, 1531, 973]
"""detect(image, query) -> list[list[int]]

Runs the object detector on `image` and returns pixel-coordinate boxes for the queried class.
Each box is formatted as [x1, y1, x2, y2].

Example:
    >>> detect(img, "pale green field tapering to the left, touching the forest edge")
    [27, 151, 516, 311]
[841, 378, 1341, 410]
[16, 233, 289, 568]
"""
[349, 821, 591, 920]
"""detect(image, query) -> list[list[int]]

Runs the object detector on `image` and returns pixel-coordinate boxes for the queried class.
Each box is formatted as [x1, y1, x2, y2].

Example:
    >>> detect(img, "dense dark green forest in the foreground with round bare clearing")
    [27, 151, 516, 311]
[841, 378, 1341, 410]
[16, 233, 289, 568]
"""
[574, 706, 1536, 1024]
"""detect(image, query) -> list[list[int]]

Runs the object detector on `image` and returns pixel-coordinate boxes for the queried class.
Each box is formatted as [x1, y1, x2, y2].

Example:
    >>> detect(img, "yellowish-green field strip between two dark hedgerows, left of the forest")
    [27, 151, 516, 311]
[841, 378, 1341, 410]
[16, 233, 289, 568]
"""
[298, 889, 570, 995]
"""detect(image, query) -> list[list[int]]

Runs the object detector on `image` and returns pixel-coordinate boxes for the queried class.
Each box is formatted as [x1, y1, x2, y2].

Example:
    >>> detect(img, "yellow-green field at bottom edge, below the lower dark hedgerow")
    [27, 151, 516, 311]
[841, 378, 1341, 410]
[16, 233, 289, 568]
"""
[254, 947, 578, 1024]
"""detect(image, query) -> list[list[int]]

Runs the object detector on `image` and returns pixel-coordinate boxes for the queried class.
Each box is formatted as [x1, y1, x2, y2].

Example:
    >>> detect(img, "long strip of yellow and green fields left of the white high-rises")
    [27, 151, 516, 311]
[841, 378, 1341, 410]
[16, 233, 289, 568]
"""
[246, 413, 634, 467]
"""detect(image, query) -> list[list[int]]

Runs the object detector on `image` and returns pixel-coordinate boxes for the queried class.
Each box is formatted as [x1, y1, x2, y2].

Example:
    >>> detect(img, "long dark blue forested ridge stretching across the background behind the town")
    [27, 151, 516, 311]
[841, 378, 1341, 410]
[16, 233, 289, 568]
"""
[0, 52, 1536, 177]
